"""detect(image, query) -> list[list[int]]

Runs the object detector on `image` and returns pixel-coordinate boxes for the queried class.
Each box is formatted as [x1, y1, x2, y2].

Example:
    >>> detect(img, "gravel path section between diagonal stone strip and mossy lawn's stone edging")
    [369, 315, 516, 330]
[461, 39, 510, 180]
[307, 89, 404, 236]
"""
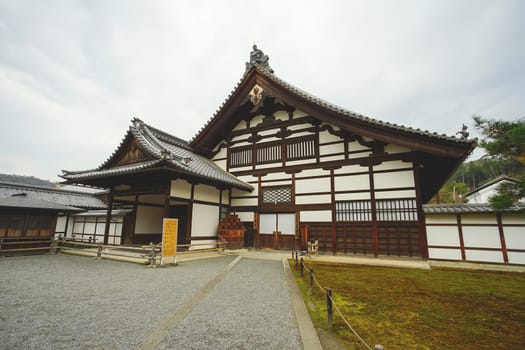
[157, 259, 302, 350]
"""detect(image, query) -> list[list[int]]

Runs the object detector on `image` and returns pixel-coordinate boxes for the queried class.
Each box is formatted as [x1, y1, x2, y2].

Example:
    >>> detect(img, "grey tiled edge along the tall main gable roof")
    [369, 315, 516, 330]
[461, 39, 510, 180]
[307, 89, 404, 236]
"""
[190, 64, 474, 144]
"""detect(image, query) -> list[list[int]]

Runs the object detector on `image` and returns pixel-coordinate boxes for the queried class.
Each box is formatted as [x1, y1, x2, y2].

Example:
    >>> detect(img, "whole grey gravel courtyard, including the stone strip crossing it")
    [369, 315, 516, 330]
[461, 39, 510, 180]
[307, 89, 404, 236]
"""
[0, 254, 302, 349]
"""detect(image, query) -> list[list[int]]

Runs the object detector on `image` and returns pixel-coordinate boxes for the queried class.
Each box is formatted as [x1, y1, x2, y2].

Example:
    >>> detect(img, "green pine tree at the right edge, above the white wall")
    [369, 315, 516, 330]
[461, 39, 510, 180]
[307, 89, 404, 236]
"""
[474, 116, 525, 210]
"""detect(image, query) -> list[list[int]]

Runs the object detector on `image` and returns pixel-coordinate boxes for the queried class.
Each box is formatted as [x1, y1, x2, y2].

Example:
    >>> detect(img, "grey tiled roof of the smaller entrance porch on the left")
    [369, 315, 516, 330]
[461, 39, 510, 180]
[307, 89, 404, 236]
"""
[62, 118, 253, 191]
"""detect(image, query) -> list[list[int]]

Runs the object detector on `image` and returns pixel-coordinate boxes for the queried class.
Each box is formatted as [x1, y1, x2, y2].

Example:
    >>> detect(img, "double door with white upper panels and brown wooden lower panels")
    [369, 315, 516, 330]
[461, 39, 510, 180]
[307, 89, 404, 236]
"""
[259, 213, 295, 249]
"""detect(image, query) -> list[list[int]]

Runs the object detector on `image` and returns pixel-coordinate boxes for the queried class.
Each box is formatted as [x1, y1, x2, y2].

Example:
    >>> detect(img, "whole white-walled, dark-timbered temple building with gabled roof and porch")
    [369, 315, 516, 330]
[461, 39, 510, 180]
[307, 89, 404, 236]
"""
[62, 46, 475, 258]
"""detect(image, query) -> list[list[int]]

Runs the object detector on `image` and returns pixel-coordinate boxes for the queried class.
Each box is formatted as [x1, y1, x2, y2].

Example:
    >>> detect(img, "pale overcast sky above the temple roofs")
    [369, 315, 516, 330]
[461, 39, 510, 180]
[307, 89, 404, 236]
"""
[0, 0, 525, 181]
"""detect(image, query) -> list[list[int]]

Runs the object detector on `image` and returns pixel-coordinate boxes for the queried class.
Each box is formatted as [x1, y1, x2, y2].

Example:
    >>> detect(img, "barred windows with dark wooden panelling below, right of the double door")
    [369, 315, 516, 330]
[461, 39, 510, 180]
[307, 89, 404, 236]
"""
[307, 198, 426, 257]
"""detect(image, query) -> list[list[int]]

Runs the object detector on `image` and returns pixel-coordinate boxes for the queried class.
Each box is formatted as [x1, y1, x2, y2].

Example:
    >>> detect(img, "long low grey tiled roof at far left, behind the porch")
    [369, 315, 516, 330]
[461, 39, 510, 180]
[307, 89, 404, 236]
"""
[0, 182, 106, 209]
